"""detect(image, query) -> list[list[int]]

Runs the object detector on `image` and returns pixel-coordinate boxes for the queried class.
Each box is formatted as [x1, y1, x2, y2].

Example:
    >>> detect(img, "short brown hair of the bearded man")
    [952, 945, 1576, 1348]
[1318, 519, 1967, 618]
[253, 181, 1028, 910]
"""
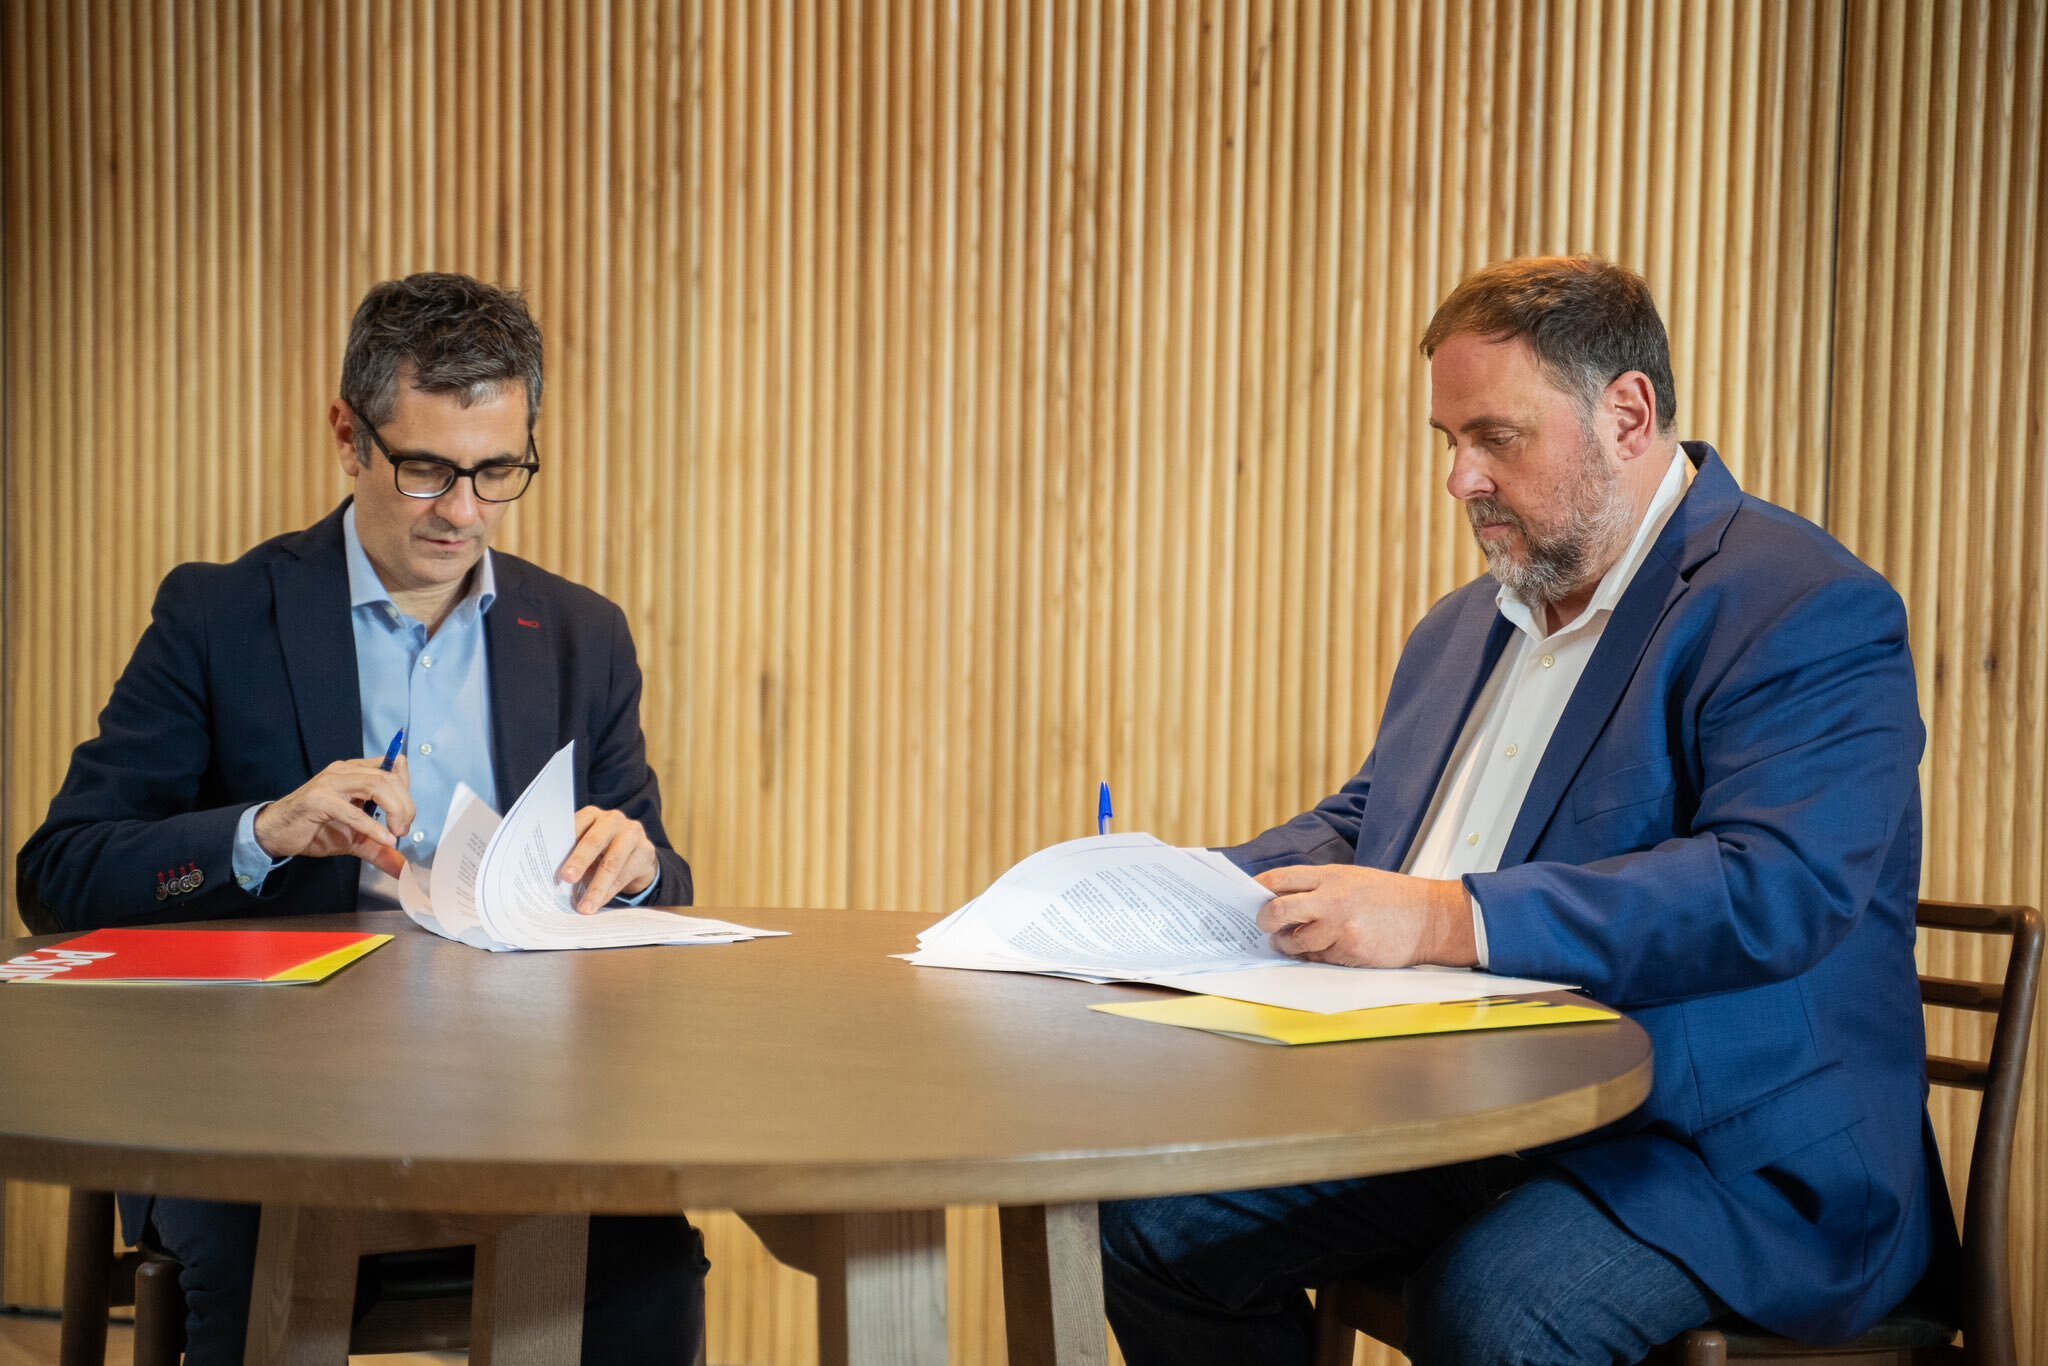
[1421, 256, 1677, 432]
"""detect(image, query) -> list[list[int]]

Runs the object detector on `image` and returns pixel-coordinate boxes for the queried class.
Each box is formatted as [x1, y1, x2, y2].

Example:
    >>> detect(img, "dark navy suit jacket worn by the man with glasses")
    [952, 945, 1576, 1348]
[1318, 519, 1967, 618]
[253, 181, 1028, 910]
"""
[16, 504, 692, 932]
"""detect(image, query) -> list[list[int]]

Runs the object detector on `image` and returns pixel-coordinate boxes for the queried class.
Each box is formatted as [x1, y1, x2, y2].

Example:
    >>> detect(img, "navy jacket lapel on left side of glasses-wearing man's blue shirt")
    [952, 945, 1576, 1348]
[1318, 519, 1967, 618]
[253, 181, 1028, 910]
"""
[270, 504, 362, 774]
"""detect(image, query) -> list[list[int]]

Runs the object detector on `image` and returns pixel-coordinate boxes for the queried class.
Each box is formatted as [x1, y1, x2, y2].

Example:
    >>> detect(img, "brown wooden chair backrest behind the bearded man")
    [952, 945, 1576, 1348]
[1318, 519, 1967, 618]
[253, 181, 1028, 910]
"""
[1917, 901, 2042, 1362]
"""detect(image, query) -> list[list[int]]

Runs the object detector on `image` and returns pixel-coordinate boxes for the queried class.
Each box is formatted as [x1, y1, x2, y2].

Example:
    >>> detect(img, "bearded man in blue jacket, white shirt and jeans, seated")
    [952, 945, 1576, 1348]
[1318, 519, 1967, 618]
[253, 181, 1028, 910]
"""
[1102, 258, 1956, 1366]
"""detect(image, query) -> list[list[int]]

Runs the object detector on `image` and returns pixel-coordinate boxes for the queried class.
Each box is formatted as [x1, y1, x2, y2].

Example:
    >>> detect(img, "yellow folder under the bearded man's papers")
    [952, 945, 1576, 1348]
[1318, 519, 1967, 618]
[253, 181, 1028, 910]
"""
[1090, 995, 1618, 1044]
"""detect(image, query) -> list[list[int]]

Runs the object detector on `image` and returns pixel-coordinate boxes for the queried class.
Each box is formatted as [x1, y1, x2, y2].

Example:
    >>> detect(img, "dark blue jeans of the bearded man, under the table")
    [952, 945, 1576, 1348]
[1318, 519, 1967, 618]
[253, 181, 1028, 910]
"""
[1102, 1157, 1726, 1366]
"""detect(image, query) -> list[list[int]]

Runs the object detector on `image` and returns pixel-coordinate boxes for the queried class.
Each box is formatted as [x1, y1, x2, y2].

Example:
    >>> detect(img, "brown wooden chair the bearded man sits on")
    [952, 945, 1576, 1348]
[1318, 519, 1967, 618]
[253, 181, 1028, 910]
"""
[1315, 901, 2042, 1366]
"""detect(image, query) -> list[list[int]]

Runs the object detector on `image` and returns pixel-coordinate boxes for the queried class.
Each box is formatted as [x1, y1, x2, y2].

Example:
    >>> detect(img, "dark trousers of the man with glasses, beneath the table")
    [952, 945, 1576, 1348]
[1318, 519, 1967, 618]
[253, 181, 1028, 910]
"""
[150, 1198, 711, 1366]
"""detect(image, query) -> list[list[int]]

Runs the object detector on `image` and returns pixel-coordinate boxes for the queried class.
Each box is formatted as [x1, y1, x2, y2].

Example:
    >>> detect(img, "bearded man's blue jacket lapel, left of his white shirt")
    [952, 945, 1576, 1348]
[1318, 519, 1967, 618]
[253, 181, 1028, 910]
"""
[1358, 592, 1513, 868]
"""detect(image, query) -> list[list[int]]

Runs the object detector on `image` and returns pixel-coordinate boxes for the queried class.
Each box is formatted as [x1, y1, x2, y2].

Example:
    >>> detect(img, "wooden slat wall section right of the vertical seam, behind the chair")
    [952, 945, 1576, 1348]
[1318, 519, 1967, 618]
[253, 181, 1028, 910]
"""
[1829, 10, 2048, 1360]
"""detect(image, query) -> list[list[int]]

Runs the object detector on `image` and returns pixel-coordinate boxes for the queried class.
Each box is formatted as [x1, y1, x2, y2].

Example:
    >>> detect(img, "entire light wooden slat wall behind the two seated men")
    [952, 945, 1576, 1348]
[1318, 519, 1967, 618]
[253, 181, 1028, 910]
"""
[0, 0, 2048, 1362]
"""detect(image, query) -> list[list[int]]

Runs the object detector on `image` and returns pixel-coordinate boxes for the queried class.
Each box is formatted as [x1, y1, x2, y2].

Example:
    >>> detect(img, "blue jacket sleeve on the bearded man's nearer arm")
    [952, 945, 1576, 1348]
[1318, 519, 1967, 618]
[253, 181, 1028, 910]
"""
[1464, 578, 1925, 1006]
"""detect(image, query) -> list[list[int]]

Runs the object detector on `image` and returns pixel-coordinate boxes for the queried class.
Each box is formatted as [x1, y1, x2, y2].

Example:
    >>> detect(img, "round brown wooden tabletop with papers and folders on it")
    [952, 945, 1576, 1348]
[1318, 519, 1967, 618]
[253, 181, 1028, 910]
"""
[0, 909, 1651, 1214]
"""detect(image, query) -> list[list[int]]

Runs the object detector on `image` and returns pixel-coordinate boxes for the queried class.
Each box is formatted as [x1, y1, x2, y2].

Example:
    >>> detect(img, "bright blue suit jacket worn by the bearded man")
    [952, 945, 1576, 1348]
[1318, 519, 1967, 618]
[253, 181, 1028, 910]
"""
[1229, 442, 1956, 1341]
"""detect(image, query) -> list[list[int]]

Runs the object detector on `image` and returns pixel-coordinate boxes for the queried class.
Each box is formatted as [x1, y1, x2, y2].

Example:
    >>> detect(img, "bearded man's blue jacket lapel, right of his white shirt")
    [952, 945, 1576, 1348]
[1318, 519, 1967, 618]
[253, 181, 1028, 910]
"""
[1501, 442, 1743, 868]
